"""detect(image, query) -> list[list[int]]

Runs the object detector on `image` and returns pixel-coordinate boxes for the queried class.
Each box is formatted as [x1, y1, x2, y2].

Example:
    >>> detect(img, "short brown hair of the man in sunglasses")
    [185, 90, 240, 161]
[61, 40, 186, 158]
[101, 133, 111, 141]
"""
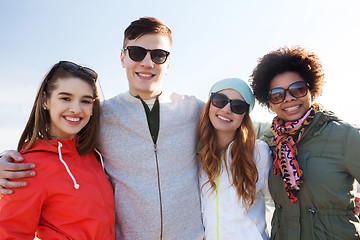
[123, 17, 172, 48]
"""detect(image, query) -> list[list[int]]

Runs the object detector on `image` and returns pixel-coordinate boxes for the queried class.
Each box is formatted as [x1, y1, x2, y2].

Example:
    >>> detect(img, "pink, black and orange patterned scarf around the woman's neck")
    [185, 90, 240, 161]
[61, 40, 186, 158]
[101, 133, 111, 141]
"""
[271, 103, 321, 203]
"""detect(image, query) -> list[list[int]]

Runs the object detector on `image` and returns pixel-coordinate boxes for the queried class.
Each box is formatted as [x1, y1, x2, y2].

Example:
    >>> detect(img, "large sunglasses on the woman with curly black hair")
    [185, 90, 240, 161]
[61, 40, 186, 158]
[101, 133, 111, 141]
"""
[268, 81, 309, 104]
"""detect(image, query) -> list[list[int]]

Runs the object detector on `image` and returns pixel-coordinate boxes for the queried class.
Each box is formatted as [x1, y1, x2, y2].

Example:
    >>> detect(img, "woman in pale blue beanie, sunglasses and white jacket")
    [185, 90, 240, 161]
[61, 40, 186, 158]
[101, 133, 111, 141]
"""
[199, 78, 271, 240]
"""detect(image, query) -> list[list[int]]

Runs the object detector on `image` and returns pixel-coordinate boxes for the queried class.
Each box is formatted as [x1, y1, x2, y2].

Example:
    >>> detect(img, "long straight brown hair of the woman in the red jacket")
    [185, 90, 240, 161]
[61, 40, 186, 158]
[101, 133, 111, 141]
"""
[17, 63, 100, 155]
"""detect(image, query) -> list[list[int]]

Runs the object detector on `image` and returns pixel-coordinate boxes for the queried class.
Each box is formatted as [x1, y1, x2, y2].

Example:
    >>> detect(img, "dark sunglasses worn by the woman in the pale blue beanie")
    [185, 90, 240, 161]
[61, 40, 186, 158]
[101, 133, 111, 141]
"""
[210, 93, 250, 114]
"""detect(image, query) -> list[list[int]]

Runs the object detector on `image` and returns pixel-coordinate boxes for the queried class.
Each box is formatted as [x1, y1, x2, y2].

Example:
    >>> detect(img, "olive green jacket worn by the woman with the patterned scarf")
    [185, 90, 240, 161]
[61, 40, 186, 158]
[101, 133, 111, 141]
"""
[263, 112, 360, 240]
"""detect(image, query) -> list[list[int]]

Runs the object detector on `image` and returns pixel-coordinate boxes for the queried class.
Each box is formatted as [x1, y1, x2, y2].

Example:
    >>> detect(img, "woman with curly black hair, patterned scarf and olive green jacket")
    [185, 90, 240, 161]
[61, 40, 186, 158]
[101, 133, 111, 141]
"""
[251, 47, 360, 239]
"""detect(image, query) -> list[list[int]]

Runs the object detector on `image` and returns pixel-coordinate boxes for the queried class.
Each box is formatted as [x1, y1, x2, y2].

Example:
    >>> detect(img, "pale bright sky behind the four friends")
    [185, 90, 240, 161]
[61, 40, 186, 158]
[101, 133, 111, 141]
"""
[0, 0, 360, 152]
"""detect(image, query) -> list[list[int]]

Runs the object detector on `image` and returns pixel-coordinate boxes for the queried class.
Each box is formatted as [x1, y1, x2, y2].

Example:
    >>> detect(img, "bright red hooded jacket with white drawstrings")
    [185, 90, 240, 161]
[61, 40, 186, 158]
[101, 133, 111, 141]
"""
[0, 138, 115, 240]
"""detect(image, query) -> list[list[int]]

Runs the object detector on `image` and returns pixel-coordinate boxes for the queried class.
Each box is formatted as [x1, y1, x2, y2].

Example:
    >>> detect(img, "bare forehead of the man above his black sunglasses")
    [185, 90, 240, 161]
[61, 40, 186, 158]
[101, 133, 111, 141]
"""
[126, 34, 171, 51]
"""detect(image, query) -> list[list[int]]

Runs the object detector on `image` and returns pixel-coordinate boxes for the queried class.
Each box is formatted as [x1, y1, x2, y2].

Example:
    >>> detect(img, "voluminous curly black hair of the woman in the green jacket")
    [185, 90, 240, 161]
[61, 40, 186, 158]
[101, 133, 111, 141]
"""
[250, 47, 325, 107]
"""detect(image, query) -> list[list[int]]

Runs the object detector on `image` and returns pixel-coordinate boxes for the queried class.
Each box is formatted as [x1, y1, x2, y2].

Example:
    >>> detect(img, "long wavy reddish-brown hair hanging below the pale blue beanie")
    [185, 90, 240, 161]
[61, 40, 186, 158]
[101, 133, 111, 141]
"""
[199, 100, 258, 209]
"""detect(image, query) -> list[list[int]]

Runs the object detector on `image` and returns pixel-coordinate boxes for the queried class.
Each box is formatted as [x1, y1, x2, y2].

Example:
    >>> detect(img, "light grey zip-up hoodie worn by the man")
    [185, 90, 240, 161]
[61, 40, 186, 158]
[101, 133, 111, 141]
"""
[99, 92, 204, 240]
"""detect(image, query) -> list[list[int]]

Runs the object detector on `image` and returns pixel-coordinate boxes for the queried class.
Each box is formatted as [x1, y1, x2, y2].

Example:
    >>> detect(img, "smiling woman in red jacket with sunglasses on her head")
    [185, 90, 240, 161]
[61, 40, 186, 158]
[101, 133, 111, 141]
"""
[0, 61, 115, 239]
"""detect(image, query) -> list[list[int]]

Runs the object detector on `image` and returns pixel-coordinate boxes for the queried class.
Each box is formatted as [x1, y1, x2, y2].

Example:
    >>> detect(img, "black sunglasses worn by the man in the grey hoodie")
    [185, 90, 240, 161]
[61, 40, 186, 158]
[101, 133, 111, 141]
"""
[124, 46, 170, 64]
